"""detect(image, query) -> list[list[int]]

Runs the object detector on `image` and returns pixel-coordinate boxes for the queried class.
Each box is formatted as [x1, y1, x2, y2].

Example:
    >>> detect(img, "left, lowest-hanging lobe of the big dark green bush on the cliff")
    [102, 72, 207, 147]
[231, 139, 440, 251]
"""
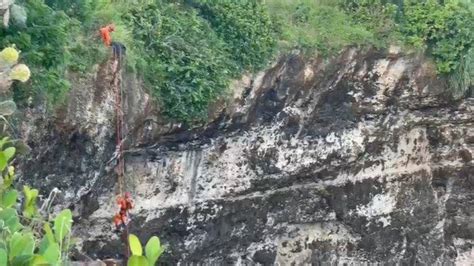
[126, 3, 235, 122]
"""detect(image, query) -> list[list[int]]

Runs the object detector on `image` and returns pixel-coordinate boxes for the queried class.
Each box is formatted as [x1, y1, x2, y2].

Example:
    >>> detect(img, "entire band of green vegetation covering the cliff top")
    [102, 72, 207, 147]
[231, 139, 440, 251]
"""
[0, 0, 474, 123]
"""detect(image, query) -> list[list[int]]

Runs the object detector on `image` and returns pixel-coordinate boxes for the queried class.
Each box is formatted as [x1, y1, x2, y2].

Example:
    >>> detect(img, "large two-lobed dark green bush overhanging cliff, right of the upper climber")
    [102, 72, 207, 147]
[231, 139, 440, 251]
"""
[122, 2, 276, 122]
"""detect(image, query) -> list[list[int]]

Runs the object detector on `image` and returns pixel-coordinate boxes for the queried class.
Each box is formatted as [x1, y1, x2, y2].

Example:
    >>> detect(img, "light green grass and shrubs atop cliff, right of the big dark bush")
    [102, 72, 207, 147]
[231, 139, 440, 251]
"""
[266, 0, 474, 97]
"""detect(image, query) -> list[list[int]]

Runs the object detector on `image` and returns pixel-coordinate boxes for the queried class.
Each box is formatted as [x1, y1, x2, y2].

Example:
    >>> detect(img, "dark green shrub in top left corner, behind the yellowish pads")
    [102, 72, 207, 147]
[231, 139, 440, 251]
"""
[0, 0, 77, 106]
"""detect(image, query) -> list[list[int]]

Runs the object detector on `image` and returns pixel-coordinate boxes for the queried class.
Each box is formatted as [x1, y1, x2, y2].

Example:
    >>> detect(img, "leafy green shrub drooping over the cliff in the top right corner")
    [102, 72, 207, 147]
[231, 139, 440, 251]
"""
[402, 0, 474, 97]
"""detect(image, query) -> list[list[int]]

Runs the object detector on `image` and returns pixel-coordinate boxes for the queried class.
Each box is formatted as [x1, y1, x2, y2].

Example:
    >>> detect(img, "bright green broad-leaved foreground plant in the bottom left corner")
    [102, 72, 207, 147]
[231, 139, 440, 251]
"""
[0, 138, 72, 265]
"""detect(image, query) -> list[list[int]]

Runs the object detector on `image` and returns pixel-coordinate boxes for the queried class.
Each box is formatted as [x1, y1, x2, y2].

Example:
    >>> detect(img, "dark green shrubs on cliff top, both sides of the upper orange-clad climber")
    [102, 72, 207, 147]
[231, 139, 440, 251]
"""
[0, 0, 276, 122]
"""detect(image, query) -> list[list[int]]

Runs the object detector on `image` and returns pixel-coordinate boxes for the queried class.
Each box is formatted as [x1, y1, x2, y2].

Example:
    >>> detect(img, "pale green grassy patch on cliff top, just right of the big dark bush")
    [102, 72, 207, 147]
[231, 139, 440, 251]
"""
[267, 0, 376, 55]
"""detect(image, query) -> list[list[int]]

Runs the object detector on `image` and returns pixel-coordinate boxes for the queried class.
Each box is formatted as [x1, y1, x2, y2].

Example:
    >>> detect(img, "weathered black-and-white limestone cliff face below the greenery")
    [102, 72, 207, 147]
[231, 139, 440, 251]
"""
[16, 49, 474, 265]
